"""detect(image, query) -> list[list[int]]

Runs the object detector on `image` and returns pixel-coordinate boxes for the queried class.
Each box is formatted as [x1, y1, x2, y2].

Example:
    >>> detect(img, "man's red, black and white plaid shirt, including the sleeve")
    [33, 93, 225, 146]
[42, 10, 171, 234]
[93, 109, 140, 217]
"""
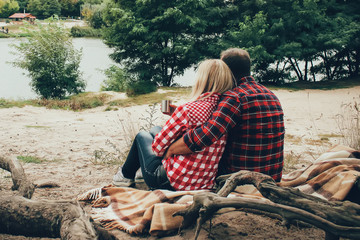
[184, 76, 285, 181]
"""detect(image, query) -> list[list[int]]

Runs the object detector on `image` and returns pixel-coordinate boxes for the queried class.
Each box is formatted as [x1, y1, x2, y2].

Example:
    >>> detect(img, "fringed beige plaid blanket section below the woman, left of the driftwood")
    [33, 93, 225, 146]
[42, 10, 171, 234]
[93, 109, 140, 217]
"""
[77, 185, 205, 235]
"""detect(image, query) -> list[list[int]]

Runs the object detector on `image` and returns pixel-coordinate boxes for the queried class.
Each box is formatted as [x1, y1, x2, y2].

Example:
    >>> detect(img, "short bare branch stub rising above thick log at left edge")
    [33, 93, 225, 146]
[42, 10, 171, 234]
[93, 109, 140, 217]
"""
[0, 157, 35, 199]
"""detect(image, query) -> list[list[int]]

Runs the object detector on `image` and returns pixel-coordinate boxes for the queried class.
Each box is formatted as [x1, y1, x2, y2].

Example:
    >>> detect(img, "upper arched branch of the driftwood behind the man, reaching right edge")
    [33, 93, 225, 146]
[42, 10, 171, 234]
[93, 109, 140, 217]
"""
[218, 171, 360, 227]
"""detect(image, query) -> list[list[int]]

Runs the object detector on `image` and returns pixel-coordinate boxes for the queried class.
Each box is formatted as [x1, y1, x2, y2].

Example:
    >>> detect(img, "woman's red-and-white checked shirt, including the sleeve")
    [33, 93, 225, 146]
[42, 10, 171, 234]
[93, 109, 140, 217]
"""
[152, 93, 226, 190]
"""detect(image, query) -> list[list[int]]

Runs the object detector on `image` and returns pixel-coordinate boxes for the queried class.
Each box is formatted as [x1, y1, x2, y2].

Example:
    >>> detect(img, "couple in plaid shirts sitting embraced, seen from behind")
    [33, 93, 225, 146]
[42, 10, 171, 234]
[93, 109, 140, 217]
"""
[113, 48, 285, 191]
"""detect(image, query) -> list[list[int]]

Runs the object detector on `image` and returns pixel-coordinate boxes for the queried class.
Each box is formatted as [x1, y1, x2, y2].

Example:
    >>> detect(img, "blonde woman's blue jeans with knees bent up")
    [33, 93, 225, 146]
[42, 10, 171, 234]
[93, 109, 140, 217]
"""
[123, 126, 173, 190]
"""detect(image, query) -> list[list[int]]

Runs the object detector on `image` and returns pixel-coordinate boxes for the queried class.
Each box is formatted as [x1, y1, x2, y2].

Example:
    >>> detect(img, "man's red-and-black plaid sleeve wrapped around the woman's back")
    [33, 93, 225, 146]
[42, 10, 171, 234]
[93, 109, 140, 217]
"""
[184, 95, 240, 152]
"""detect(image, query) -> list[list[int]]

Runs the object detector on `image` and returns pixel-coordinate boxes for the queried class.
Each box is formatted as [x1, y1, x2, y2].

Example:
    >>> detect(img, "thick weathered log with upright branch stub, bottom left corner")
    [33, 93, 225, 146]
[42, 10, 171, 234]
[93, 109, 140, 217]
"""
[0, 157, 115, 240]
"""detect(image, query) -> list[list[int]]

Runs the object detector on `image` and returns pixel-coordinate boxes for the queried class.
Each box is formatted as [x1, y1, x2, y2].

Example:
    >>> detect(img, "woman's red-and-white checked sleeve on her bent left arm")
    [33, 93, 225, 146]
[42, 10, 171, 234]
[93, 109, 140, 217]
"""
[152, 105, 189, 156]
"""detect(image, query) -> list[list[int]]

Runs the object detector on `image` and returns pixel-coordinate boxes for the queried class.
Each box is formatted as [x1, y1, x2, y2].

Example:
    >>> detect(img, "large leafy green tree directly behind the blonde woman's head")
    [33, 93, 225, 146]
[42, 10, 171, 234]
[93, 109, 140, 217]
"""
[103, 0, 235, 86]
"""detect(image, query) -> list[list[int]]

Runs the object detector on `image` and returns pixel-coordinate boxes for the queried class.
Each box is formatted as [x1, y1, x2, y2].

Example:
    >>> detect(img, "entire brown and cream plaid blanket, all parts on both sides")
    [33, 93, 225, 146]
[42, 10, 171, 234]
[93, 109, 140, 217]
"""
[77, 146, 360, 235]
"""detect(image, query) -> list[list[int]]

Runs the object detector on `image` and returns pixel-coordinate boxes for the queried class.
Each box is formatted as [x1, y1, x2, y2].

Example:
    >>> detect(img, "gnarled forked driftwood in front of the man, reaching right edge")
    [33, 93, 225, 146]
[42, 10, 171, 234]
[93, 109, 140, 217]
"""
[174, 171, 360, 239]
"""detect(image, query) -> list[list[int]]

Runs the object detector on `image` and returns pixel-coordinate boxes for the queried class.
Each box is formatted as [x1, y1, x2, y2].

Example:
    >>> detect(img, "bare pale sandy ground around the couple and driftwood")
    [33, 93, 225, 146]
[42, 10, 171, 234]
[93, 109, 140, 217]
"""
[0, 86, 360, 239]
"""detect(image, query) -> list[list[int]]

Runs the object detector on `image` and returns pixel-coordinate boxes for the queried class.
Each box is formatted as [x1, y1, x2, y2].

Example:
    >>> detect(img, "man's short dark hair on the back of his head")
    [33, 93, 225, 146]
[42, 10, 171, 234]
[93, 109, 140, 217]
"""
[220, 48, 251, 80]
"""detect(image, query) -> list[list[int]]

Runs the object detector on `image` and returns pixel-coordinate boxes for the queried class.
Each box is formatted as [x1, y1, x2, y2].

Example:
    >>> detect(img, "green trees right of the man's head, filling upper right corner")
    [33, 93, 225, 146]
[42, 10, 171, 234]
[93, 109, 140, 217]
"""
[227, 0, 360, 84]
